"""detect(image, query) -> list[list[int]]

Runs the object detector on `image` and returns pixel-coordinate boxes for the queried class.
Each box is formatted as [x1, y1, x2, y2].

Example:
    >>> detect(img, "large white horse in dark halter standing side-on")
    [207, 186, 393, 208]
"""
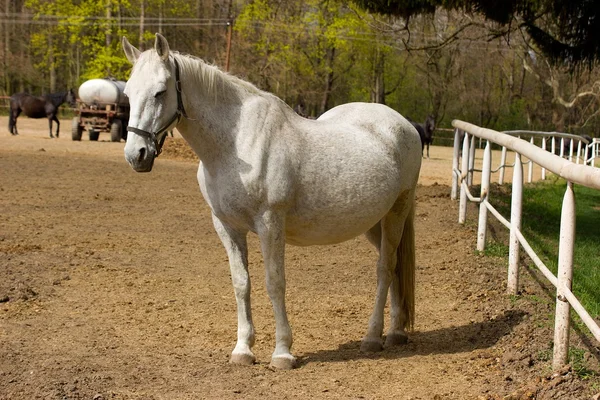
[123, 34, 421, 369]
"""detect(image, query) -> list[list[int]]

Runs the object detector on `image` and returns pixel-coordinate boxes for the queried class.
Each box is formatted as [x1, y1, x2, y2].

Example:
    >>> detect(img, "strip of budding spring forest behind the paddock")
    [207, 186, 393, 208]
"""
[0, 0, 600, 137]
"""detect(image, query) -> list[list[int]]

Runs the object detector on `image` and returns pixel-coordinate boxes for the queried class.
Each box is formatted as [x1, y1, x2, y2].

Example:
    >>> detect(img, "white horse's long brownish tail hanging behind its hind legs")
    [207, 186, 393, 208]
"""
[396, 198, 416, 330]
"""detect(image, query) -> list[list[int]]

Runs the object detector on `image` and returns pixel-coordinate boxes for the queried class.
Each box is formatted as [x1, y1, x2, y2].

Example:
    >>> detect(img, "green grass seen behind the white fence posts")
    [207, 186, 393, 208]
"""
[490, 179, 600, 318]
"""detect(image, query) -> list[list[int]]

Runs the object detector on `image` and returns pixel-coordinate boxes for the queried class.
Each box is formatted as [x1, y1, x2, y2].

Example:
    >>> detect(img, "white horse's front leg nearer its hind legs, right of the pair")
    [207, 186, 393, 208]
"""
[258, 210, 296, 369]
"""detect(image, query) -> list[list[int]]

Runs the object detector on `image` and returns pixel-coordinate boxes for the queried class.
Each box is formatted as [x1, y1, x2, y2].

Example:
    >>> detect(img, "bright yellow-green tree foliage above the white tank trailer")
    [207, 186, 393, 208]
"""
[18, 0, 196, 87]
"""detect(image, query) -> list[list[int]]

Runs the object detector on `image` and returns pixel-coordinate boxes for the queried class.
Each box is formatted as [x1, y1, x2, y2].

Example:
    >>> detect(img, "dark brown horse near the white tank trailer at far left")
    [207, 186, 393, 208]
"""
[8, 89, 76, 138]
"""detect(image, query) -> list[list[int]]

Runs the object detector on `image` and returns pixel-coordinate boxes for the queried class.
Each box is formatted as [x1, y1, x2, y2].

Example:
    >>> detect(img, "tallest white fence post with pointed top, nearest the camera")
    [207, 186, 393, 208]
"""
[552, 182, 575, 370]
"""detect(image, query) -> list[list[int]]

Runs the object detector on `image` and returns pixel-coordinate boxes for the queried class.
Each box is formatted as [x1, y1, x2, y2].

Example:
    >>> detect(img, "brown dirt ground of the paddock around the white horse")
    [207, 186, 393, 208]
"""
[0, 117, 600, 400]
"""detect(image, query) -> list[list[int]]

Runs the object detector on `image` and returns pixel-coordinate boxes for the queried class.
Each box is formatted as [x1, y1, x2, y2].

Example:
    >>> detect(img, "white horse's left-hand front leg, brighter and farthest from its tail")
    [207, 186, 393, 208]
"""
[213, 215, 256, 365]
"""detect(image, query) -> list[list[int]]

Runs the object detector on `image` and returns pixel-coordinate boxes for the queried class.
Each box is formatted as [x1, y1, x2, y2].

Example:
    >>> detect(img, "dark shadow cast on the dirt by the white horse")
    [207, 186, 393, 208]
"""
[298, 310, 526, 366]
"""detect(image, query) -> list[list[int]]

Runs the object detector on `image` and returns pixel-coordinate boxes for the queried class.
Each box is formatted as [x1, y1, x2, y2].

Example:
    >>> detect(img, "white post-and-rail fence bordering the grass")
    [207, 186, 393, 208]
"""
[451, 120, 600, 370]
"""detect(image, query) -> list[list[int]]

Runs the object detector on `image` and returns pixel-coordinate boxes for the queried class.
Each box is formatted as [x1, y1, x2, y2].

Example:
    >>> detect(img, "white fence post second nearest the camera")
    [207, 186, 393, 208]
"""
[507, 152, 523, 295]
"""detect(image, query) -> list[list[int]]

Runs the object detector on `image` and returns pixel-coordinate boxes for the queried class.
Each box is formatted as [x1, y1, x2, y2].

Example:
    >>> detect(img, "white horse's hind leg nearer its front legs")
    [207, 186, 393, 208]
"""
[361, 190, 414, 351]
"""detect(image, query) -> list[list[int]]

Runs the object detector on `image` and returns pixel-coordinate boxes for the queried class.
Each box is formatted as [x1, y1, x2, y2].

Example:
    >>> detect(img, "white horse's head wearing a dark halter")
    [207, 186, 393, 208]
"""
[123, 33, 183, 172]
